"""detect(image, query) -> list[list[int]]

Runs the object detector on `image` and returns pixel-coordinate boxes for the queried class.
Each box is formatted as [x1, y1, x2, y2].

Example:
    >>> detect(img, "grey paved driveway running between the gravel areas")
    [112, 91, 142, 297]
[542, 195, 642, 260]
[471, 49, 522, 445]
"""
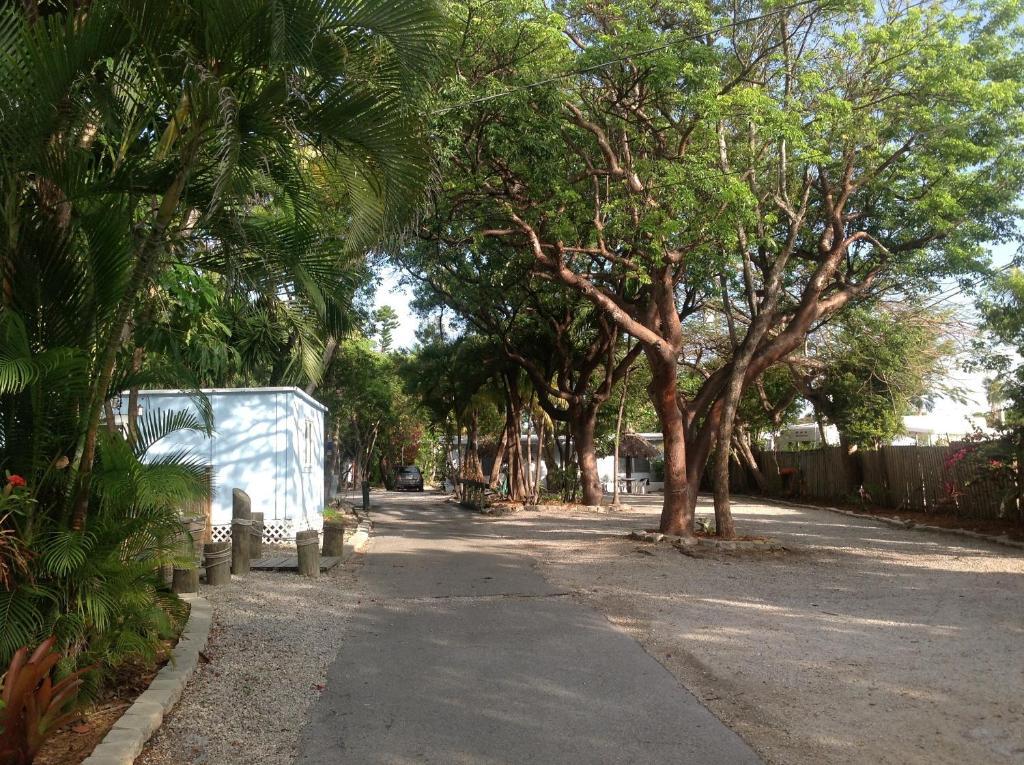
[298, 494, 760, 765]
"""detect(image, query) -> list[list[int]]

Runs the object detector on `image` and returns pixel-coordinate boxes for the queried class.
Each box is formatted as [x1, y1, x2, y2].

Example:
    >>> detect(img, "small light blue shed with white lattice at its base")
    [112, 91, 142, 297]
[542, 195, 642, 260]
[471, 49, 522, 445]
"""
[119, 388, 327, 542]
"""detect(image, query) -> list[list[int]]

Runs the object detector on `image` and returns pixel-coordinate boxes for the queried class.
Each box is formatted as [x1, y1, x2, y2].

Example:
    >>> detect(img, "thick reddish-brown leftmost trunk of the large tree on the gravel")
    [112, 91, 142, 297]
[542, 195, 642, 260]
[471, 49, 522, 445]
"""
[645, 348, 699, 537]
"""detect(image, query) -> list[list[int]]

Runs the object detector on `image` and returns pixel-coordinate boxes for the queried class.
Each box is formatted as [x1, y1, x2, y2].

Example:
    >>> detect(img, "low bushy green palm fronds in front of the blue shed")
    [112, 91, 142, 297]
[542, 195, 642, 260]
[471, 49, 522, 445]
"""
[0, 422, 210, 668]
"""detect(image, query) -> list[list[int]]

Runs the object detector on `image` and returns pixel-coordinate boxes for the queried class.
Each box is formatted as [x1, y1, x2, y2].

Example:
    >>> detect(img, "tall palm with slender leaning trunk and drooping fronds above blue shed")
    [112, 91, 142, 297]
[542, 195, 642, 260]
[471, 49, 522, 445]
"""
[0, 0, 438, 527]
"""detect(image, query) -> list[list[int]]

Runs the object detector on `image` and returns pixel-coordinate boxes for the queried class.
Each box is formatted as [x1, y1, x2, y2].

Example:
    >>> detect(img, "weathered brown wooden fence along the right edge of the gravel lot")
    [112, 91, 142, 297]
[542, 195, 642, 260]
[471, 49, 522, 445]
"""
[730, 444, 1015, 518]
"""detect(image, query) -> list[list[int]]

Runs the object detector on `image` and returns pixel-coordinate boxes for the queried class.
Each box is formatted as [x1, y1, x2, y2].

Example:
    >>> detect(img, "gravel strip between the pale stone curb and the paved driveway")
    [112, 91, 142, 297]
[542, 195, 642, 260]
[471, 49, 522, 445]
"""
[136, 557, 360, 765]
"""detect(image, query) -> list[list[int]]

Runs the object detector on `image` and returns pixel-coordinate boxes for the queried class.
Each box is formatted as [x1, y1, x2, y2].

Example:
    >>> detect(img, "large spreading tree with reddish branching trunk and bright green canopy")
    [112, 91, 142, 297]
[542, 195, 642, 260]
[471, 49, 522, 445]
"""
[425, 0, 1022, 535]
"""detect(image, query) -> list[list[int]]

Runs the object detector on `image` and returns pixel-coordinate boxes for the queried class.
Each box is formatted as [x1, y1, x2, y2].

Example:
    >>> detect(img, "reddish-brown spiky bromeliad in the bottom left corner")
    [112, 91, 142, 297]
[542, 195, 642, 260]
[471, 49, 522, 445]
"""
[0, 636, 91, 765]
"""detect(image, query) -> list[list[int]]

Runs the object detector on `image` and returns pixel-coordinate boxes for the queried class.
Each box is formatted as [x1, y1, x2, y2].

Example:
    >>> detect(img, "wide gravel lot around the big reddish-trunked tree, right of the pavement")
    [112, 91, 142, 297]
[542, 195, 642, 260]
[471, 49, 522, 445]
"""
[493, 496, 1024, 765]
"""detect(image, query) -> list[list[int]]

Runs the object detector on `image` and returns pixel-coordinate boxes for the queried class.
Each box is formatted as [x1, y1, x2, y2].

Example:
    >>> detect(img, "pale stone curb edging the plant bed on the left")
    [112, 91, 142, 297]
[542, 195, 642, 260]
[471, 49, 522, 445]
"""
[82, 595, 213, 765]
